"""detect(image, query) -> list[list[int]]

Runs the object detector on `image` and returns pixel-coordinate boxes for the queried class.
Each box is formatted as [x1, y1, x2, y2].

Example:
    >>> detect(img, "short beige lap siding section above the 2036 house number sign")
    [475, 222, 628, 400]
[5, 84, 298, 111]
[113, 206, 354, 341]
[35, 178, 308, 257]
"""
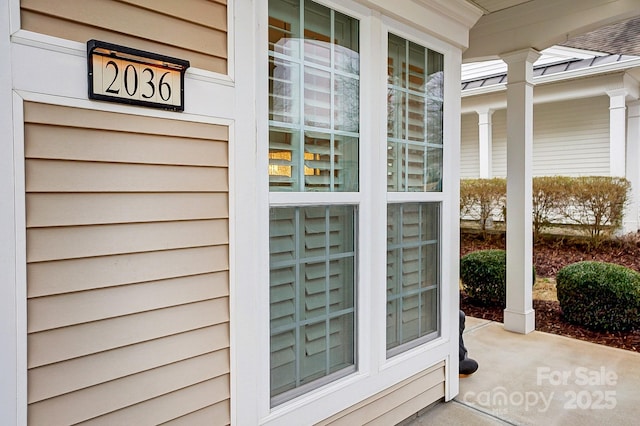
[20, 0, 228, 74]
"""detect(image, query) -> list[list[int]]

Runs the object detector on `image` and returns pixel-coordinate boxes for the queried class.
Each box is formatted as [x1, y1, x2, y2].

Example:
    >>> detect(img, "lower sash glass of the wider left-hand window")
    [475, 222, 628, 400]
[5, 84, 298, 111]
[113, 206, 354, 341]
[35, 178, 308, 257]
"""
[269, 206, 356, 402]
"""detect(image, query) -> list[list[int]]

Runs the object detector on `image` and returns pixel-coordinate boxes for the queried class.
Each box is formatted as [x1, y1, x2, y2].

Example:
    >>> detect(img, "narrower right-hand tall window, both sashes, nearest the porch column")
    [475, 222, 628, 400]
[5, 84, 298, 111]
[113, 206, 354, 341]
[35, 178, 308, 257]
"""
[387, 34, 444, 356]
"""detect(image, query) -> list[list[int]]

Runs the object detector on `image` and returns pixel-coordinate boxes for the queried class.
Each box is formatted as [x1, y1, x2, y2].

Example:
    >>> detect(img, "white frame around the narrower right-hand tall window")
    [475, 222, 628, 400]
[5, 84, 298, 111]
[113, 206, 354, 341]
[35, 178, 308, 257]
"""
[374, 16, 461, 371]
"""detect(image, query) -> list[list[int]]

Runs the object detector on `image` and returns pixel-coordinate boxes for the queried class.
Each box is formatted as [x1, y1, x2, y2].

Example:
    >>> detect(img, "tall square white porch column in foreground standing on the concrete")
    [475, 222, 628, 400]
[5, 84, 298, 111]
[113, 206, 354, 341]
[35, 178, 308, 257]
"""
[502, 49, 540, 334]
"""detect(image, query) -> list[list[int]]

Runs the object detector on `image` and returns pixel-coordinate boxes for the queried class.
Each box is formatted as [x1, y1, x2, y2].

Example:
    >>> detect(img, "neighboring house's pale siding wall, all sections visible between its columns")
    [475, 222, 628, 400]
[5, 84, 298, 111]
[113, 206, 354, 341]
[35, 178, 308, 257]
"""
[461, 96, 609, 178]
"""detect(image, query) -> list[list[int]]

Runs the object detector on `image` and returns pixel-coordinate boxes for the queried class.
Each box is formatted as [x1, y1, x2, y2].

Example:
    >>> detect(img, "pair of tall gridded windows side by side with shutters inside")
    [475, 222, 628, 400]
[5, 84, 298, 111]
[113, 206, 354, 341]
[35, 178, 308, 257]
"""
[268, 0, 444, 407]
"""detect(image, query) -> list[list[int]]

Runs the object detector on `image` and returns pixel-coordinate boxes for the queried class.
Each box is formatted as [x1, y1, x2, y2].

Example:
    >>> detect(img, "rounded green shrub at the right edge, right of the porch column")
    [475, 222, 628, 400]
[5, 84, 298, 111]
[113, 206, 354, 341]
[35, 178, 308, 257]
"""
[556, 261, 640, 331]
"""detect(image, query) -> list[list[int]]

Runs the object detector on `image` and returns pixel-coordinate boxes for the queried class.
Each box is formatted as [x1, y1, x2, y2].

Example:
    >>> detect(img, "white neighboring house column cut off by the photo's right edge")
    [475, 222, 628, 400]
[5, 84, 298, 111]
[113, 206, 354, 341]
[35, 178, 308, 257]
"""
[623, 101, 640, 234]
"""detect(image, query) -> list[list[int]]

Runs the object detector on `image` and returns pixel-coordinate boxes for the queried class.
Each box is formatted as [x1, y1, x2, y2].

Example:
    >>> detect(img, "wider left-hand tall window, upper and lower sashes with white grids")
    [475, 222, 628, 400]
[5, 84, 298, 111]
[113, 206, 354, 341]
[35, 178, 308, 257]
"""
[269, 0, 360, 406]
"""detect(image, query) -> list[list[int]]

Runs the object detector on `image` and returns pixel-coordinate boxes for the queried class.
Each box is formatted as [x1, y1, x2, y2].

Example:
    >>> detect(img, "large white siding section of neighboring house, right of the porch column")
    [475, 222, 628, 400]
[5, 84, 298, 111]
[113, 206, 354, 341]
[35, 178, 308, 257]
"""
[533, 96, 609, 176]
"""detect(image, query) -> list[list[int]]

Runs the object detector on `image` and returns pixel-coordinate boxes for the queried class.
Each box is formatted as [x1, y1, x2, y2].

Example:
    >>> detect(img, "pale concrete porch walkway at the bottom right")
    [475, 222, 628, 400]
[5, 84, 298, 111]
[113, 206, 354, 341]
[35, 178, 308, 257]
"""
[406, 317, 640, 426]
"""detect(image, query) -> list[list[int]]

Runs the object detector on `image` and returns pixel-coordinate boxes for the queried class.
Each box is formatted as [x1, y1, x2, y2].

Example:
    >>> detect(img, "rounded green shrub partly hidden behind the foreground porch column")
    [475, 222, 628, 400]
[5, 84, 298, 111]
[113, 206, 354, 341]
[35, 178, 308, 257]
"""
[460, 250, 536, 307]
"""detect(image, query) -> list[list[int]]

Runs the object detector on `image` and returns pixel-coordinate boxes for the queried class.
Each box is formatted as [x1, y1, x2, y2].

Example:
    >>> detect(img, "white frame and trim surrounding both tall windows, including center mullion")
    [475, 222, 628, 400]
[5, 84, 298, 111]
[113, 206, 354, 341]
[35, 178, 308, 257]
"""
[251, 0, 461, 423]
